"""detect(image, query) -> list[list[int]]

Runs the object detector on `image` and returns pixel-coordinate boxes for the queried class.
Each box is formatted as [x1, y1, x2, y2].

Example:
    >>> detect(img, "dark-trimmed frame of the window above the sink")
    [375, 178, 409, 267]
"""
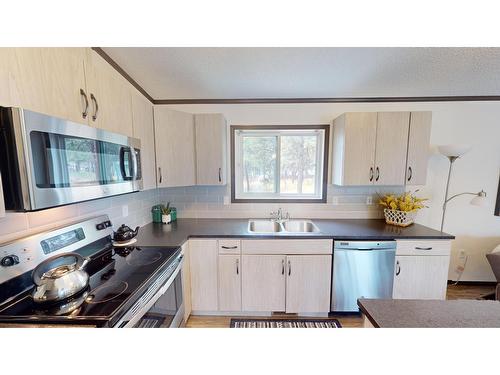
[230, 124, 330, 203]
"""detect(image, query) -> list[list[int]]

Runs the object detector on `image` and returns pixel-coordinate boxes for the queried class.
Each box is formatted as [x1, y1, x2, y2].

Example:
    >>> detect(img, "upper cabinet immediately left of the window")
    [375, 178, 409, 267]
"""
[195, 113, 227, 185]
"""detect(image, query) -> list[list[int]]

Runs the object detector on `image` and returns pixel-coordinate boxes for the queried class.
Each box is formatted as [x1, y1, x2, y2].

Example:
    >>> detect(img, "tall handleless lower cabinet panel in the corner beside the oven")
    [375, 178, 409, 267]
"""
[189, 240, 218, 311]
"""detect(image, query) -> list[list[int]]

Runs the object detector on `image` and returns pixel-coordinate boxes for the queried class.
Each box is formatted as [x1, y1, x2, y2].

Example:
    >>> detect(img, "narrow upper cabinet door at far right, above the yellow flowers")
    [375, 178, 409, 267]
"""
[406, 112, 432, 185]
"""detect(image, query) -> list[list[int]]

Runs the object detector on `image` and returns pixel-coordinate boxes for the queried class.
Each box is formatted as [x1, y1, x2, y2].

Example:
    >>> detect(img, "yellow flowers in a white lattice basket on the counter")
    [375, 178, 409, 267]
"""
[378, 190, 427, 227]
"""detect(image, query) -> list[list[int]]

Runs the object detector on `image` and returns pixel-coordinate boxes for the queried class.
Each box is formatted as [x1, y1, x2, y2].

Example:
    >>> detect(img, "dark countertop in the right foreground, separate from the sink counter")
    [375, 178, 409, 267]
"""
[358, 299, 500, 328]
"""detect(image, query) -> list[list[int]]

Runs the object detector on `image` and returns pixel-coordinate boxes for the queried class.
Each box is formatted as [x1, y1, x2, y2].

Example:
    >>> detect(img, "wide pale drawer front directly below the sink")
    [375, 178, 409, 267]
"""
[241, 239, 333, 255]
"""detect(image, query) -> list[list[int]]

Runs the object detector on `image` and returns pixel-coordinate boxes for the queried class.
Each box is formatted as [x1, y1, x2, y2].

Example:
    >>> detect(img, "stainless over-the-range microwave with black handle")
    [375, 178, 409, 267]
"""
[7, 109, 142, 210]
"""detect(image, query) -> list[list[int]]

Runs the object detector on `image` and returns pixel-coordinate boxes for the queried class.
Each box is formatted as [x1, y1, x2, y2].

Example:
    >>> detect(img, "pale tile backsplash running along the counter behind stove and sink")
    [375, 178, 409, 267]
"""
[0, 185, 403, 243]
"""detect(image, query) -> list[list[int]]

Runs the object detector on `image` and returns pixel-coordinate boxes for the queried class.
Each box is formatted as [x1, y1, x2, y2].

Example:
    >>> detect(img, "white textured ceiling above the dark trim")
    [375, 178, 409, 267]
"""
[104, 47, 500, 99]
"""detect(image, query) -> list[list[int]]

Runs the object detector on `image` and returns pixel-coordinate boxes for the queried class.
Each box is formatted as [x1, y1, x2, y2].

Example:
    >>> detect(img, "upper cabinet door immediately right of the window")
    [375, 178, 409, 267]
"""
[332, 112, 376, 186]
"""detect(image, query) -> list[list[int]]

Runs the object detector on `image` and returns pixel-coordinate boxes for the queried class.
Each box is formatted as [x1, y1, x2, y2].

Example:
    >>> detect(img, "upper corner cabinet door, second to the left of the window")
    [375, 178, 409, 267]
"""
[154, 106, 196, 187]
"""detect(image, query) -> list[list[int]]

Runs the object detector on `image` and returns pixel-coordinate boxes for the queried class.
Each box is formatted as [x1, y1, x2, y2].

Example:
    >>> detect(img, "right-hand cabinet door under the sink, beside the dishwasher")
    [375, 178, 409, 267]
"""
[286, 255, 332, 313]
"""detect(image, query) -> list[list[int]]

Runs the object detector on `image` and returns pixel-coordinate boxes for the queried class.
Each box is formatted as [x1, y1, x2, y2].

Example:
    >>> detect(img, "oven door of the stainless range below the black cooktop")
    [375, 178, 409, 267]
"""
[115, 255, 184, 328]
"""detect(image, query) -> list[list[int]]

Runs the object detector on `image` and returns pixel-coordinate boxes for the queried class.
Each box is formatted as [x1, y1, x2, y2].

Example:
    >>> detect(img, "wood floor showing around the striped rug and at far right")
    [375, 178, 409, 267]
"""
[186, 285, 494, 328]
